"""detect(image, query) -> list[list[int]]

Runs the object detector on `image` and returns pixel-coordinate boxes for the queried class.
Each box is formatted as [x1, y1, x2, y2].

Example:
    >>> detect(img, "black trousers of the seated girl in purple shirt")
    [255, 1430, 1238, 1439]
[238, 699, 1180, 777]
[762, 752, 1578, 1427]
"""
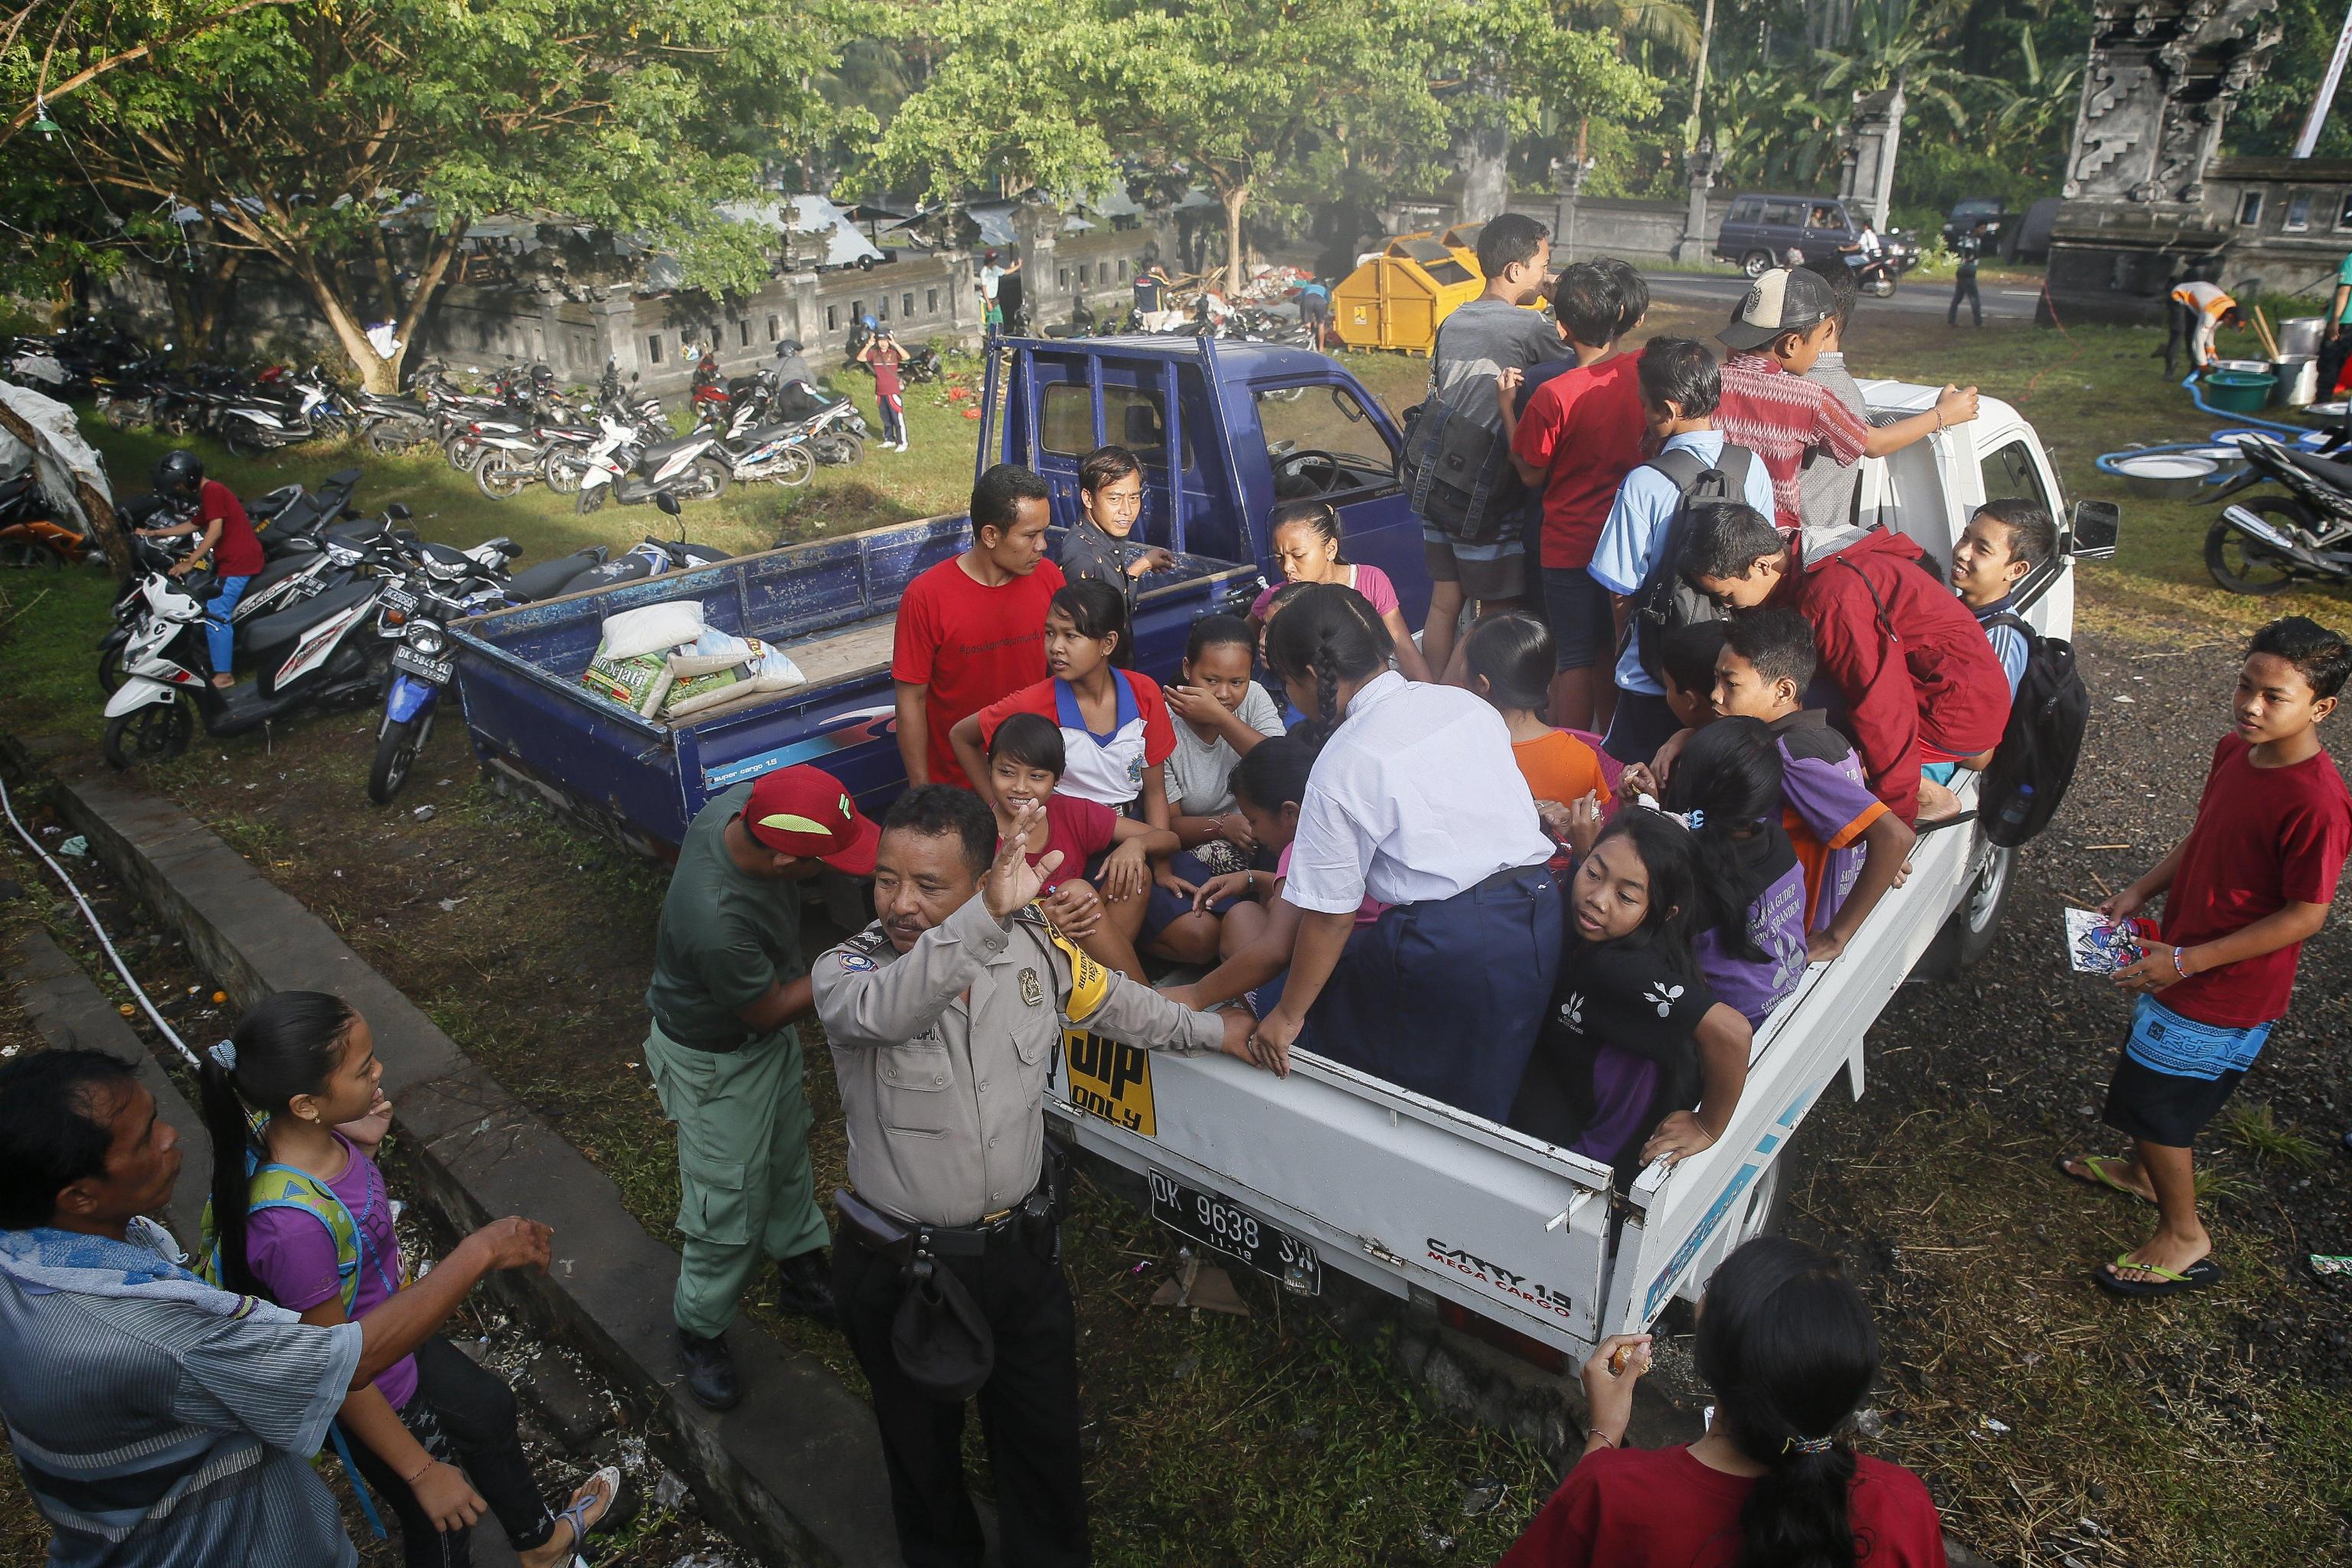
[344, 1338, 555, 1568]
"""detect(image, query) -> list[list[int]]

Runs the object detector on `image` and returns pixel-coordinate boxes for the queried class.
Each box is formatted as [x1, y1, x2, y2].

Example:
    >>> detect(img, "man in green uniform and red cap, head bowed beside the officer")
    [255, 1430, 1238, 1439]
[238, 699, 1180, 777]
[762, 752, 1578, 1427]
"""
[645, 766, 880, 1410]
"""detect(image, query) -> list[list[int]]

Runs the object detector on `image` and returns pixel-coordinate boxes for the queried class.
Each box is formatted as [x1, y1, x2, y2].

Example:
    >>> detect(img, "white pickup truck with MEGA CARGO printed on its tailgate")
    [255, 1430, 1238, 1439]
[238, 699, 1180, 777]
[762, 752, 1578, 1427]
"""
[1049, 381, 2117, 1366]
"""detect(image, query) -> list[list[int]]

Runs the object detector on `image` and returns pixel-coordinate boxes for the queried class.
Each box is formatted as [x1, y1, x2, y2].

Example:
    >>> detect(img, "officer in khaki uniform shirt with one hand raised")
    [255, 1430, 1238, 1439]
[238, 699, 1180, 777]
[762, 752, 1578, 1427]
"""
[812, 786, 1286, 1568]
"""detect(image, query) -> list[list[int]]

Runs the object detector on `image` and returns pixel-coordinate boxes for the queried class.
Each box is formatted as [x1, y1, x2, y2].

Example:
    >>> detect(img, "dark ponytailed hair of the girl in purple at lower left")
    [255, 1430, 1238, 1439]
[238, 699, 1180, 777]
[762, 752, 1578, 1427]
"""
[198, 992, 358, 1295]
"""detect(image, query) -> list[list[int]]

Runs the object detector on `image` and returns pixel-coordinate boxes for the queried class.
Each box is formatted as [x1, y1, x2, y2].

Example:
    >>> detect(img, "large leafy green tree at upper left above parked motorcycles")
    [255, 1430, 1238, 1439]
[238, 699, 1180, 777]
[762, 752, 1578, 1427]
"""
[32, 0, 863, 390]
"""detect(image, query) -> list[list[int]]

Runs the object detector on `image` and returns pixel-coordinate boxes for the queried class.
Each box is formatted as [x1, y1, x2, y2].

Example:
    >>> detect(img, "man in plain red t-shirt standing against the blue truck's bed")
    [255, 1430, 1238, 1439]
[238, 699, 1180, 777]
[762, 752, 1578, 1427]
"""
[889, 463, 1063, 790]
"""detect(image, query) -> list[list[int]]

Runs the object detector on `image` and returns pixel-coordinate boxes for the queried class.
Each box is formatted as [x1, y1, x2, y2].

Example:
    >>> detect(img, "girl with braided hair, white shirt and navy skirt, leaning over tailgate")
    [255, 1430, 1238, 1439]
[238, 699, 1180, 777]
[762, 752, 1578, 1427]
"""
[1256, 583, 1562, 1122]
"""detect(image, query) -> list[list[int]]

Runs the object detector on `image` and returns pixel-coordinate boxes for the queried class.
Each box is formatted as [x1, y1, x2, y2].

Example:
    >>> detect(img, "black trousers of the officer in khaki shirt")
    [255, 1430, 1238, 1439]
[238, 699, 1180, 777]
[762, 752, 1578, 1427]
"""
[832, 1227, 1091, 1568]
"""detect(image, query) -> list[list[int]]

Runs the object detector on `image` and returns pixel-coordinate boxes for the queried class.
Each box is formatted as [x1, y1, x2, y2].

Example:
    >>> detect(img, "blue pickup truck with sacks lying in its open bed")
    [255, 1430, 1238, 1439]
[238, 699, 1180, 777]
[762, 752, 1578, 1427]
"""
[452, 336, 1430, 854]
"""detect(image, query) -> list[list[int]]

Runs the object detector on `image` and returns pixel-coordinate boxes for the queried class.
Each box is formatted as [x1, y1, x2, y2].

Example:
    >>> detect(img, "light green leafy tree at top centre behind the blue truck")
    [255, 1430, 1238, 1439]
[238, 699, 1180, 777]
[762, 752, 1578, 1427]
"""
[873, 0, 1654, 289]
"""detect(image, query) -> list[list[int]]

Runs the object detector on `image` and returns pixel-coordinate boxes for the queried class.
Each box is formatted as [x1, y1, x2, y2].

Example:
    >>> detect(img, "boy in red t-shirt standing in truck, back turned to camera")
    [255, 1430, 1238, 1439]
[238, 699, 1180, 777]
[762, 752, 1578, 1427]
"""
[1496, 261, 1648, 729]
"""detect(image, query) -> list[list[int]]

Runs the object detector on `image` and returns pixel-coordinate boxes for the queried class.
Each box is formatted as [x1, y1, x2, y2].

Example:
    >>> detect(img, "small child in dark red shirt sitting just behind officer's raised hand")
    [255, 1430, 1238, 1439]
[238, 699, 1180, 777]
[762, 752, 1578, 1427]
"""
[988, 712, 1176, 980]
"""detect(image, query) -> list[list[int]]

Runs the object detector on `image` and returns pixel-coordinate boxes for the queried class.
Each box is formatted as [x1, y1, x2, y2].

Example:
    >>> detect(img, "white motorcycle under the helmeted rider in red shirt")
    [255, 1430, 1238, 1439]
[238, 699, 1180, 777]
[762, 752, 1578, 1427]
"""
[101, 538, 388, 769]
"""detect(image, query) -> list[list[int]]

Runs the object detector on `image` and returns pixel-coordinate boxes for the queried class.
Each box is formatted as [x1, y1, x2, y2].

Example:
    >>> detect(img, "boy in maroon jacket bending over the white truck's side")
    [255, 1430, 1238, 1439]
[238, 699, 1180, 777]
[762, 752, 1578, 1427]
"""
[1681, 503, 2008, 828]
